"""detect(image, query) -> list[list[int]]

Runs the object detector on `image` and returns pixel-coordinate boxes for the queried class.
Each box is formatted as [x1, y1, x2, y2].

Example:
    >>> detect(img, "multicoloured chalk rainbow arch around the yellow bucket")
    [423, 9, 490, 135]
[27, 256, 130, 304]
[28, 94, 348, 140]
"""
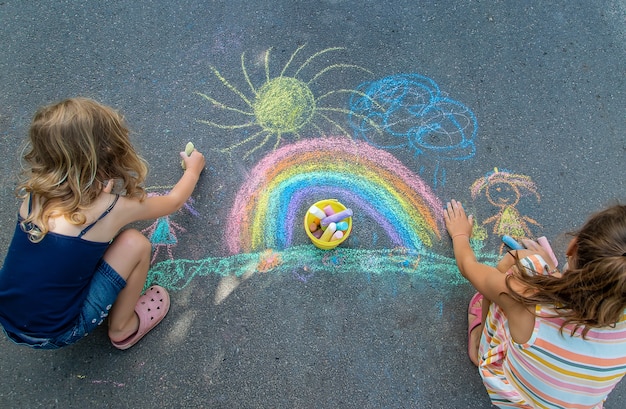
[225, 137, 443, 254]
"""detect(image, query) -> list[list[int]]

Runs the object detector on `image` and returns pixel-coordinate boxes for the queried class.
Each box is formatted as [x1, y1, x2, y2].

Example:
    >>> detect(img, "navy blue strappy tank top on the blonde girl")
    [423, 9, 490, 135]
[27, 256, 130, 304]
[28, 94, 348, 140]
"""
[0, 196, 119, 338]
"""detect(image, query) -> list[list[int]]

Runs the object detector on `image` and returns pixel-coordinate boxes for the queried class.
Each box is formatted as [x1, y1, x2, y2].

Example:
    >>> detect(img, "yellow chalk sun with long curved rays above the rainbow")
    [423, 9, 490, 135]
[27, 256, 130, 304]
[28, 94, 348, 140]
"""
[197, 45, 376, 159]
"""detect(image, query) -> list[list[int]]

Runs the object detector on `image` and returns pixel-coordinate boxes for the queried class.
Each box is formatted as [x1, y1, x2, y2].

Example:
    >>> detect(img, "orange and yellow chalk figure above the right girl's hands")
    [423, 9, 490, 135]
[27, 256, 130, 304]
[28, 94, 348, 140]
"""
[470, 168, 541, 254]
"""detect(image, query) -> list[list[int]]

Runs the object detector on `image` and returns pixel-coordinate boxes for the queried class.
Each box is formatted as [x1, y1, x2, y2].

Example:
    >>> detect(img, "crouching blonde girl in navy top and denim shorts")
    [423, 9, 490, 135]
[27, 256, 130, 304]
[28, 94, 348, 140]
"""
[0, 98, 205, 349]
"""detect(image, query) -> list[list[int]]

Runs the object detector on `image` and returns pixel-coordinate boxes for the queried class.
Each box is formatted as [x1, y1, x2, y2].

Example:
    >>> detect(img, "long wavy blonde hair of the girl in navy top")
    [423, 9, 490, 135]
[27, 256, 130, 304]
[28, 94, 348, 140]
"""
[17, 98, 147, 241]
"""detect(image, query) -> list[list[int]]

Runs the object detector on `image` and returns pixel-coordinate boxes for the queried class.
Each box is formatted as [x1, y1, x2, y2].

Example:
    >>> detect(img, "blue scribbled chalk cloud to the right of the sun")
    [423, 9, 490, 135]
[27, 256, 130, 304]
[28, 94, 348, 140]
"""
[349, 74, 478, 187]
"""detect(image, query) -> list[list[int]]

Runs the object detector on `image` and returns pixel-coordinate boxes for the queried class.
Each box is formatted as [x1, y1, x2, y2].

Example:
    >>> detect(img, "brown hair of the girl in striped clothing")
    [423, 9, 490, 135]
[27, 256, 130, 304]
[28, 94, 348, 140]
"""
[507, 205, 626, 336]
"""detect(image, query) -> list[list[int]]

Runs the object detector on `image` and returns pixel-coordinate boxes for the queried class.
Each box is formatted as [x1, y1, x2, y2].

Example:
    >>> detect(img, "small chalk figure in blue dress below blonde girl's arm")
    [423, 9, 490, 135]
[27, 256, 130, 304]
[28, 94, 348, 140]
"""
[141, 188, 199, 264]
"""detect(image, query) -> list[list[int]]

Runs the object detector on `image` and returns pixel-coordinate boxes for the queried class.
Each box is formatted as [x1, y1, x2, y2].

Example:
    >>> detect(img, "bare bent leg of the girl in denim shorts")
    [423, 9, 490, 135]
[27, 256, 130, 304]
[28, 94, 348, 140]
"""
[104, 229, 152, 342]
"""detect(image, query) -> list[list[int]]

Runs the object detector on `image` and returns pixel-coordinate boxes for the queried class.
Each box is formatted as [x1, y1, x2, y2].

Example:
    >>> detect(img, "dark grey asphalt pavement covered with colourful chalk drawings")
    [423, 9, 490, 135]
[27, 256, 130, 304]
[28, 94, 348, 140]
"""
[0, 0, 626, 409]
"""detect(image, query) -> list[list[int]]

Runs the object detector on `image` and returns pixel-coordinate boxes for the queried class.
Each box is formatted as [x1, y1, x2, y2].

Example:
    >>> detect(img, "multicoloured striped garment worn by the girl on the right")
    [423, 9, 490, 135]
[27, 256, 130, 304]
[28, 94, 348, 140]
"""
[479, 256, 626, 409]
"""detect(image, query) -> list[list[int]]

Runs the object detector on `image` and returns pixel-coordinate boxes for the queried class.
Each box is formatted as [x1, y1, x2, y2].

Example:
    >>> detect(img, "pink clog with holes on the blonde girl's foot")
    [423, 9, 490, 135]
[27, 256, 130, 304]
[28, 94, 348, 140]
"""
[111, 285, 170, 349]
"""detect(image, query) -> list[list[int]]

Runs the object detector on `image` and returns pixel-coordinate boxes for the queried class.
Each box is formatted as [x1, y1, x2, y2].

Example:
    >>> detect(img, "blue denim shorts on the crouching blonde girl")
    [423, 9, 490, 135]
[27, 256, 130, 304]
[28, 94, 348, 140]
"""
[5, 260, 126, 349]
